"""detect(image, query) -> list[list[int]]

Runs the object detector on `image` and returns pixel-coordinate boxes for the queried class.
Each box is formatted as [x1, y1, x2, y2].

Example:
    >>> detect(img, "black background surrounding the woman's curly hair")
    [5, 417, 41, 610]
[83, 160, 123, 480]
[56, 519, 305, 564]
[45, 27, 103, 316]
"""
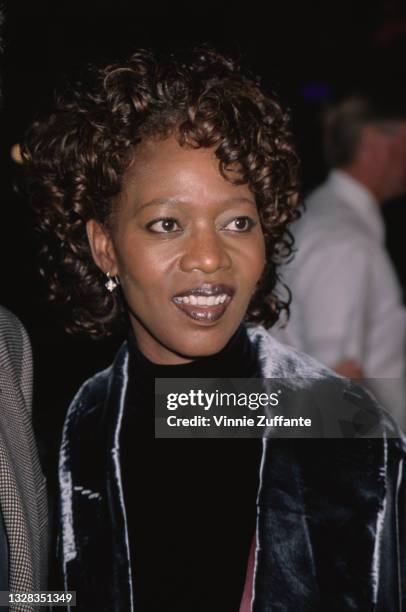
[0, 0, 406, 464]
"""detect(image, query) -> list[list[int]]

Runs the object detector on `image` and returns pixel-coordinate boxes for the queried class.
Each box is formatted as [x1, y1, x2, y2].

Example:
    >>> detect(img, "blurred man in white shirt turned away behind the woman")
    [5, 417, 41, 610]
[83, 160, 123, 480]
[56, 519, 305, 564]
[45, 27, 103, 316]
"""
[276, 97, 406, 425]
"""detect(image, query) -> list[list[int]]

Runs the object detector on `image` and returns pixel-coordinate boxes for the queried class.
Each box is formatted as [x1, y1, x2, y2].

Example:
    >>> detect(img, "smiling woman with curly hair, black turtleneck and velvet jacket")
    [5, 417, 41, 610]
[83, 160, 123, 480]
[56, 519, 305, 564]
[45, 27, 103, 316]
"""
[24, 48, 403, 612]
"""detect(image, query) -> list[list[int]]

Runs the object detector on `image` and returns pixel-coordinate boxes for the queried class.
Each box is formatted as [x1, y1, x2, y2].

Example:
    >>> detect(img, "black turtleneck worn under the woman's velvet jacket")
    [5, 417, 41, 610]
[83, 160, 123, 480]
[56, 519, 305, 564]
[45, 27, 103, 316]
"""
[121, 326, 261, 612]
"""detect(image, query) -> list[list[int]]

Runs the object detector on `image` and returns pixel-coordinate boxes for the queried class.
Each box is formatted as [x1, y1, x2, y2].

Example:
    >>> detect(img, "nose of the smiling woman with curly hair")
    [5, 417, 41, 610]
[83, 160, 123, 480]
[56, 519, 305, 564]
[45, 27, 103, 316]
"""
[180, 229, 231, 274]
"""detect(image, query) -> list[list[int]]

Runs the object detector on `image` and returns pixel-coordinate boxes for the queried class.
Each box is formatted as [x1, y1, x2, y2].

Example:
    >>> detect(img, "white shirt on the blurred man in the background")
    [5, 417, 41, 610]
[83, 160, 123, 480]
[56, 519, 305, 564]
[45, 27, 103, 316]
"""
[273, 170, 406, 424]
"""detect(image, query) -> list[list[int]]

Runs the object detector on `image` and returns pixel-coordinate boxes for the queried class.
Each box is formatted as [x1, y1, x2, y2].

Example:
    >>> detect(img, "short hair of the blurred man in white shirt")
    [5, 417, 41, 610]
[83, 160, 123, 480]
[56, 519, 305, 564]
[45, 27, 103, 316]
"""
[323, 95, 406, 168]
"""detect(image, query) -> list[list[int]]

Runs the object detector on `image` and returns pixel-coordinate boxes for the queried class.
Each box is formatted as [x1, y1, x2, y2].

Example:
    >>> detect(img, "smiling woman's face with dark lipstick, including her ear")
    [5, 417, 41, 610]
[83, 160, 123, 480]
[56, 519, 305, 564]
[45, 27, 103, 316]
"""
[88, 137, 265, 364]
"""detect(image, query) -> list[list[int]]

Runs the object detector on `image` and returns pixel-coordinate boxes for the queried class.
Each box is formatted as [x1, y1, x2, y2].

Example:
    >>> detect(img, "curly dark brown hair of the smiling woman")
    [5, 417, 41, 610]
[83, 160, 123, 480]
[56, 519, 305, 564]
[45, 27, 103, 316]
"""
[22, 47, 299, 337]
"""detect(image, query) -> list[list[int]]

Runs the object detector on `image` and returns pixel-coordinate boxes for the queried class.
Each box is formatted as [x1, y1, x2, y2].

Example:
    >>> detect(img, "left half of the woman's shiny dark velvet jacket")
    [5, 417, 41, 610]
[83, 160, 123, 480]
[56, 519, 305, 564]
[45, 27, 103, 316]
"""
[59, 344, 133, 612]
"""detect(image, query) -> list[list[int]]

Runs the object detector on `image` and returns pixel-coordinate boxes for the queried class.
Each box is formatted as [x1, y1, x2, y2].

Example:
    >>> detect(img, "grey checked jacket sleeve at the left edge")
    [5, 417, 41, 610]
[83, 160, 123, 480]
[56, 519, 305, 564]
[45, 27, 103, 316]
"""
[0, 307, 47, 612]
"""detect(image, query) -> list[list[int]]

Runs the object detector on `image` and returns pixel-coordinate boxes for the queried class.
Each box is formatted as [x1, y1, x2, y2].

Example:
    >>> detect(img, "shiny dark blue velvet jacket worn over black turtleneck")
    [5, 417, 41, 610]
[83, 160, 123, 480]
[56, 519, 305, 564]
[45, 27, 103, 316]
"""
[59, 327, 406, 612]
